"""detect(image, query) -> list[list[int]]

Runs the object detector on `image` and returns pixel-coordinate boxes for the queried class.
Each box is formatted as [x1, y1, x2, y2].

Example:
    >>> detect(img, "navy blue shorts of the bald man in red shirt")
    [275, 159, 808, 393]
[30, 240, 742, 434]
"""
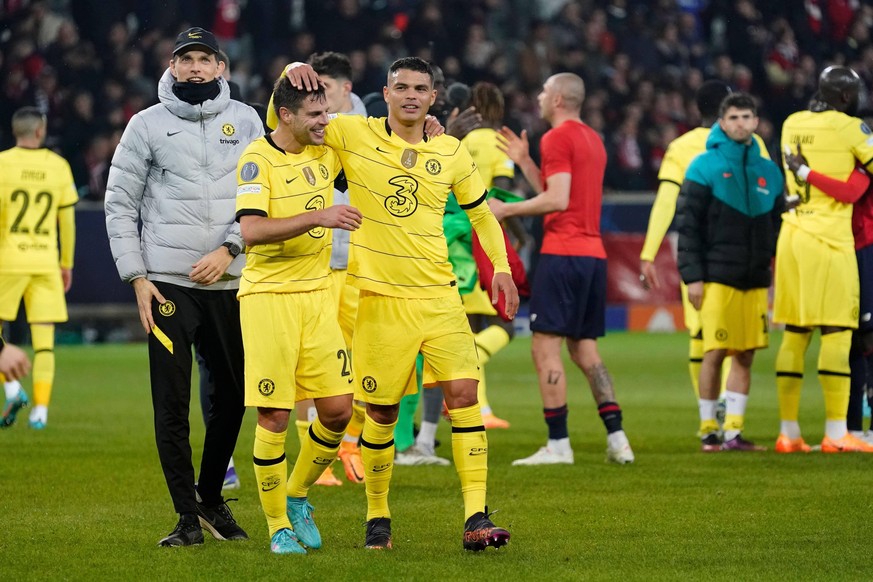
[530, 255, 606, 339]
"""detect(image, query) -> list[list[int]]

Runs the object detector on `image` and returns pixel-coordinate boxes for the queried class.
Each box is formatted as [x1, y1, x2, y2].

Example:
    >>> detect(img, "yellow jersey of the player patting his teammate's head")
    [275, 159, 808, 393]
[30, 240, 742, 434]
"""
[325, 115, 498, 298]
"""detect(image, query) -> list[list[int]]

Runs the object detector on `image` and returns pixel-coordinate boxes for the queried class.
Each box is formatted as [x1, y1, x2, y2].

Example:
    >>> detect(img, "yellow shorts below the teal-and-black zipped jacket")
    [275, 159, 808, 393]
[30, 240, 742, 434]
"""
[700, 283, 769, 353]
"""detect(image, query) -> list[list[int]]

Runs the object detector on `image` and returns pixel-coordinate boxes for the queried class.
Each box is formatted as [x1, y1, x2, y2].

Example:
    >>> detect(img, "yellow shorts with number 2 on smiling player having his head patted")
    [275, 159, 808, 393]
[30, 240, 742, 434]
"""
[240, 289, 354, 410]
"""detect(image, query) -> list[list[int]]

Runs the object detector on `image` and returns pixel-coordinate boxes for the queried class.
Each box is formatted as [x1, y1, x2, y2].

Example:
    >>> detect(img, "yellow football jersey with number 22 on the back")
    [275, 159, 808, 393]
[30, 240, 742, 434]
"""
[0, 147, 79, 274]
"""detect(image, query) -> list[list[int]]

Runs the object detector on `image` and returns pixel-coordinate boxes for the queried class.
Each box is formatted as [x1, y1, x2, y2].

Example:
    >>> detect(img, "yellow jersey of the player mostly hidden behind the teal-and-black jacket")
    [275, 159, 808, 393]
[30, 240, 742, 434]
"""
[640, 127, 770, 261]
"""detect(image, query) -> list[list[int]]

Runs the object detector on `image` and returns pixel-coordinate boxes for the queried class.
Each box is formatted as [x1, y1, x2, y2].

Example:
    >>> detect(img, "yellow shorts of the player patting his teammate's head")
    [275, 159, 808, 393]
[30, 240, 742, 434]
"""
[352, 291, 479, 405]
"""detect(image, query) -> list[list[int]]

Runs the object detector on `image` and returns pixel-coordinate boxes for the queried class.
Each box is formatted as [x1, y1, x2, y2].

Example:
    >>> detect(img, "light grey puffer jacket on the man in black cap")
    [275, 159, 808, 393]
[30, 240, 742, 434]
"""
[105, 69, 264, 290]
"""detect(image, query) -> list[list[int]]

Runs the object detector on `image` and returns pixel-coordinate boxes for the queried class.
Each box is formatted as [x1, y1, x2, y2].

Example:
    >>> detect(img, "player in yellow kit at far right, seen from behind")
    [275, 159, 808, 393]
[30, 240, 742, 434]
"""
[773, 66, 873, 453]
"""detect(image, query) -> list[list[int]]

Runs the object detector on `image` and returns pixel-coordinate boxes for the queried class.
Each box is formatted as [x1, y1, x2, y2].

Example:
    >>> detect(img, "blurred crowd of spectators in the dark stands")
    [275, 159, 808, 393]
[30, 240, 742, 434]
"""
[0, 0, 873, 200]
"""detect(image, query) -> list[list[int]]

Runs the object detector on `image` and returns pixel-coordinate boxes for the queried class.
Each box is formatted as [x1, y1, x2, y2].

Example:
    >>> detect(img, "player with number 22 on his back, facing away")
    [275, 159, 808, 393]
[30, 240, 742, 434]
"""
[0, 107, 79, 429]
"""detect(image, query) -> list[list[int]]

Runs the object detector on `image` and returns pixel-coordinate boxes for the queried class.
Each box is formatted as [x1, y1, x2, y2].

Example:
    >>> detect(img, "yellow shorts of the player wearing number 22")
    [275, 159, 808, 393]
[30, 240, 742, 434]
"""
[0, 268, 68, 323]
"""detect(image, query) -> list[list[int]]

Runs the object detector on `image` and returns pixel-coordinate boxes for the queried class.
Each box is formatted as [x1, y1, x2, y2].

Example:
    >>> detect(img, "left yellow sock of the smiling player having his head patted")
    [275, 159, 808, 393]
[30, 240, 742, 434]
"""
[254, 425, 291, 537]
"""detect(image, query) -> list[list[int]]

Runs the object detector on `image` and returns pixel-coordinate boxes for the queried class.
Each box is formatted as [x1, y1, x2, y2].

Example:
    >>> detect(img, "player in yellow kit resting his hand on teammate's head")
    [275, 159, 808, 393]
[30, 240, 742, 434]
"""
[282, 57, 518, 550]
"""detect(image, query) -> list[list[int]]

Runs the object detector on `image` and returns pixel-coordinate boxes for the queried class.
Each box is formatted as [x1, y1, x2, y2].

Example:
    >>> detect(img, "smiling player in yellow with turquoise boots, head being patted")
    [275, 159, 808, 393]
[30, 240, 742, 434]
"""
[236, 77, 361, 554]
